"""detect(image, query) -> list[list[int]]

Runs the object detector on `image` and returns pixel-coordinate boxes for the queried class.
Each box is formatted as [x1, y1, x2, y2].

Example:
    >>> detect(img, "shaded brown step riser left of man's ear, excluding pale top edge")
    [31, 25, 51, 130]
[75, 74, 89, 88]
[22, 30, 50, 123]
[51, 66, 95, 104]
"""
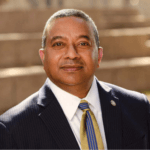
[0, 39, 42, 68]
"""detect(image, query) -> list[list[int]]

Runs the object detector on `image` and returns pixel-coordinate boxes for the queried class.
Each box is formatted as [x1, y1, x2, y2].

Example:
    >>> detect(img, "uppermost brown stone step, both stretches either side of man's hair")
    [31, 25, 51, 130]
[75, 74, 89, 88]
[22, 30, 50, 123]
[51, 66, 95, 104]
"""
[0, 8, 146, 33]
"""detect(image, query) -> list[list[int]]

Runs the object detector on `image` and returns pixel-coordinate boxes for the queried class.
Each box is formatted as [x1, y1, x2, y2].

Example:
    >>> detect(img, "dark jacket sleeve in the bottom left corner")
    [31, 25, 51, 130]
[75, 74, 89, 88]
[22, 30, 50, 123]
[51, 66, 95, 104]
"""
[0, 122, 17, 149]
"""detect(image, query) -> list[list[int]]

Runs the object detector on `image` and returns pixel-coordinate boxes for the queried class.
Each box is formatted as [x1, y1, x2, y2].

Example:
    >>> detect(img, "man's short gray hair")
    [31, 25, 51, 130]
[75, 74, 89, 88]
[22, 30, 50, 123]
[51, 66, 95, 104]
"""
[42, 9, 100, 49]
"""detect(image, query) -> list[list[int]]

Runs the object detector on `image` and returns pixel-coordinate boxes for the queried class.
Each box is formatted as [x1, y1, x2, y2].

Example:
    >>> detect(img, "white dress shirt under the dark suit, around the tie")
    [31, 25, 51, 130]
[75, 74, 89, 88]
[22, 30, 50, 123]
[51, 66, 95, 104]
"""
[48, 77, 107, 150]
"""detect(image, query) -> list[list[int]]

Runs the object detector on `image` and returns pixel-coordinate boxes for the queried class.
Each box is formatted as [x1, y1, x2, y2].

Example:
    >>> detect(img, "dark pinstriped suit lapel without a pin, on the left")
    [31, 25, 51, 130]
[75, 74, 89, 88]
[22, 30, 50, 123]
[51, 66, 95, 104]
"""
[38, 79, 79, 149]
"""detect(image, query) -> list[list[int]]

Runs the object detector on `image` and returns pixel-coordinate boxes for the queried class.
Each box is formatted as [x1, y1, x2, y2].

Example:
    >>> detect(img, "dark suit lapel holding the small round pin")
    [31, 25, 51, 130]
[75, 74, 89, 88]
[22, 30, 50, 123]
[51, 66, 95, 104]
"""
[97, 82, 122, 149]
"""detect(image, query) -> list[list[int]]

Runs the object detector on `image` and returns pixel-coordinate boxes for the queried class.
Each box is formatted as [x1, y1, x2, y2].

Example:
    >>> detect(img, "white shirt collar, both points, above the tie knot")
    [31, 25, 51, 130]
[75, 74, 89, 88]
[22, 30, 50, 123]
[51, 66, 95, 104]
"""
[48, 77, 99, 120]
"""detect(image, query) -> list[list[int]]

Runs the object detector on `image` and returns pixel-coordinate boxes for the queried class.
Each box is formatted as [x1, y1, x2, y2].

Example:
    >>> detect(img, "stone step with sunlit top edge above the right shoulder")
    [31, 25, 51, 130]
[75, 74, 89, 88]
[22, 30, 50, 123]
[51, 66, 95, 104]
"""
[96, 57, 150, 91]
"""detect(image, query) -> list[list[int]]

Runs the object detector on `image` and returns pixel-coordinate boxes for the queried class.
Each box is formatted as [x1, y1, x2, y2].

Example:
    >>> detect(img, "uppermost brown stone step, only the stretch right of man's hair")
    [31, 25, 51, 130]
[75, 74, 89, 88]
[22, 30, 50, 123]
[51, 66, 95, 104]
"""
[83, 8, 142, 29]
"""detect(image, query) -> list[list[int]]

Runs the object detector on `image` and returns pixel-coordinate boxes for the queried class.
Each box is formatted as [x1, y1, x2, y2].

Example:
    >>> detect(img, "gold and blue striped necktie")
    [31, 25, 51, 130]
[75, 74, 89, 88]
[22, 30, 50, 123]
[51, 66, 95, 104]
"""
[79, 100, 104, 150]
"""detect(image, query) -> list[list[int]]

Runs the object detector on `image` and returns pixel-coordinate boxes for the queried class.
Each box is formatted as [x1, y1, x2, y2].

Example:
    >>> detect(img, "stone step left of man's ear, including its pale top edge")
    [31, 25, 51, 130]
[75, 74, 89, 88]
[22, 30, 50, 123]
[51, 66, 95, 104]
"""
[0, 33, 42, 68]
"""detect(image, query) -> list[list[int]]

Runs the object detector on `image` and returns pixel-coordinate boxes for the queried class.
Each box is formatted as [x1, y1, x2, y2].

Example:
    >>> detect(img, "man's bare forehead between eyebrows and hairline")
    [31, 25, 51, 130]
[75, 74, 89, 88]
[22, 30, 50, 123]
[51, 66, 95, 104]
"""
[47, 16, 93, 37]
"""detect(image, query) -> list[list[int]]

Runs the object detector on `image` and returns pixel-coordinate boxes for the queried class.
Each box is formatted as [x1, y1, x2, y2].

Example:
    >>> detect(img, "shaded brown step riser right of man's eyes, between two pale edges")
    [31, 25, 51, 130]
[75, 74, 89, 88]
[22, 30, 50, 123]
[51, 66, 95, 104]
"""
[100, 35, 150, 60]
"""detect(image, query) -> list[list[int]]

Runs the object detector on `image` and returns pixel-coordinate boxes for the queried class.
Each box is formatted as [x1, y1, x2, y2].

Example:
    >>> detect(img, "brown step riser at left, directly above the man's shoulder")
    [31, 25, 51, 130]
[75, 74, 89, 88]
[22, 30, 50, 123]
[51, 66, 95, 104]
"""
[0, 74, 46, 114]
